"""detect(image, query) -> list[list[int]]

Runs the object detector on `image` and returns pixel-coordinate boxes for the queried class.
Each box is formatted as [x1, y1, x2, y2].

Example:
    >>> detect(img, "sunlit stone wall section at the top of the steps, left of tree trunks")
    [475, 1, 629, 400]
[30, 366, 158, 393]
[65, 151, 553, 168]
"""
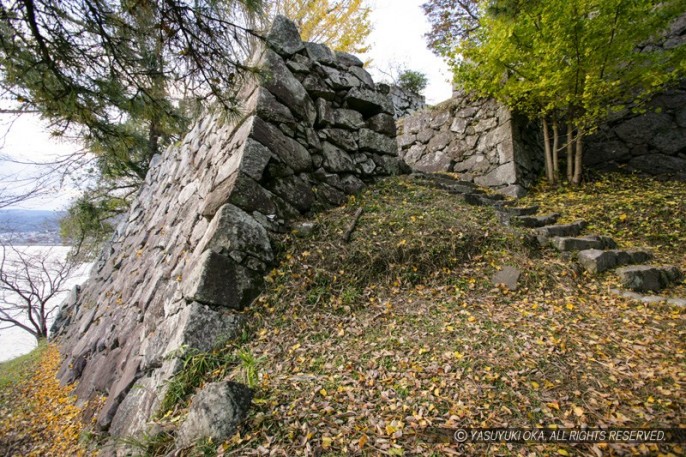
[397, 92, 542, 196]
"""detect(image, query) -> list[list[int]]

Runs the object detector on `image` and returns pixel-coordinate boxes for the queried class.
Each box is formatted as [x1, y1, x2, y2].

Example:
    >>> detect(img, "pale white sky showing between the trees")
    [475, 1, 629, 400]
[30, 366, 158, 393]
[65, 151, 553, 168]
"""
[0, 0, 451, 210]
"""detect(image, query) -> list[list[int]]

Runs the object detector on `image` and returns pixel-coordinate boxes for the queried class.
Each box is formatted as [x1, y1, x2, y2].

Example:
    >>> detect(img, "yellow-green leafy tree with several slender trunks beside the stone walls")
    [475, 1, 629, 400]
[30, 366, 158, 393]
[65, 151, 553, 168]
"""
[428, 0, 686, 184]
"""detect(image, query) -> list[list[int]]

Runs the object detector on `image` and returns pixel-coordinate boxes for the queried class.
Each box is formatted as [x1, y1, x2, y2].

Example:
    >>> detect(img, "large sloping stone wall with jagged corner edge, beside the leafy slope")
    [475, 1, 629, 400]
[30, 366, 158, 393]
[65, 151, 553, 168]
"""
[54, 18, 400, 436]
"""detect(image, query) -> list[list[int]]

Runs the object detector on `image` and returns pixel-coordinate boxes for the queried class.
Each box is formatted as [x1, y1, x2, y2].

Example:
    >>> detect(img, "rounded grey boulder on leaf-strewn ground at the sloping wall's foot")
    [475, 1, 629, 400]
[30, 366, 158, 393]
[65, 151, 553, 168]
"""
[177, 381, 252, 447]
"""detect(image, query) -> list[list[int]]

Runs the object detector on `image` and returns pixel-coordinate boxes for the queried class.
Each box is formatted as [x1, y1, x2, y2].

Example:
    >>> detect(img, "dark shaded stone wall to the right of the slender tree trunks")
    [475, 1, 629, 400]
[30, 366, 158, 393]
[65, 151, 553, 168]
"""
[584, 81, 686, 179]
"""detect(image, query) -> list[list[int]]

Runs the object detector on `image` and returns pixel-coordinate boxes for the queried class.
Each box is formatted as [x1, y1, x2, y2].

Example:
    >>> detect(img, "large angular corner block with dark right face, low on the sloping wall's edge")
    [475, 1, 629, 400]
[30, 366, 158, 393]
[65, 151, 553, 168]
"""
[182, 250, 262, 310]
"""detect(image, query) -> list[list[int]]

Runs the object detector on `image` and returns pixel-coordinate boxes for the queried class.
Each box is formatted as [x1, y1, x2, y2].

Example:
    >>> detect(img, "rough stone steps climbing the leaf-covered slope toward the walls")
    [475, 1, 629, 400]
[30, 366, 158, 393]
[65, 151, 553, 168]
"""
[411, 173, 686, 306]
